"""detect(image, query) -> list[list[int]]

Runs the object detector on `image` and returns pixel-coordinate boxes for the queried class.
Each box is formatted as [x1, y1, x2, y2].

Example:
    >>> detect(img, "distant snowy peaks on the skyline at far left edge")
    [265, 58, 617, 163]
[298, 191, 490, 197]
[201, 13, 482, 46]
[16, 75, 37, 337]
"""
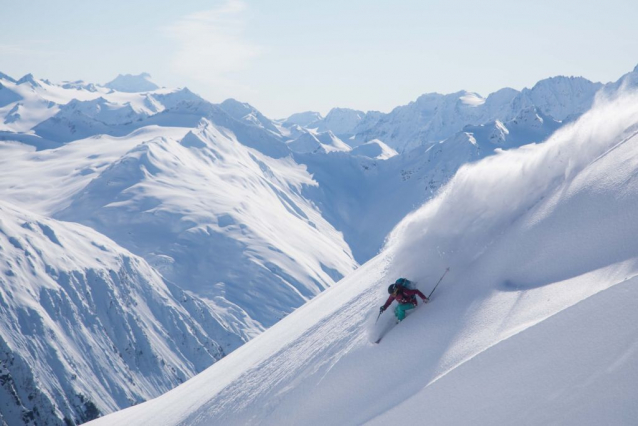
[0, 74, 198, 140]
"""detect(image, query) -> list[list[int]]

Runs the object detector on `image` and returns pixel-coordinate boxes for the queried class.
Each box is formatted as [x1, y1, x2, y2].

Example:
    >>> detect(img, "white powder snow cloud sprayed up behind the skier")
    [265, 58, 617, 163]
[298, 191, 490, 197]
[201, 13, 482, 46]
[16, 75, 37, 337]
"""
[386, 92, 638, 285]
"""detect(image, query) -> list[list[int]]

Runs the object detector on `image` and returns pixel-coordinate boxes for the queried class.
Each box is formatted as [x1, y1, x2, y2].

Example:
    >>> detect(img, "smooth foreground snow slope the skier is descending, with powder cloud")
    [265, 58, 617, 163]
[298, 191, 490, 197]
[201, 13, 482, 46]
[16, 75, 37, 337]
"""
[91, 89, 638, 425]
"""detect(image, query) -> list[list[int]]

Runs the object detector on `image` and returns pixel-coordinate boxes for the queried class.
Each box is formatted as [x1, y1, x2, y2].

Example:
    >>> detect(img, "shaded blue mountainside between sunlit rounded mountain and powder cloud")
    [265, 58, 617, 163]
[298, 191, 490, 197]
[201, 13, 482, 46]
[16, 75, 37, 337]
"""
[293, 103, 561, 263]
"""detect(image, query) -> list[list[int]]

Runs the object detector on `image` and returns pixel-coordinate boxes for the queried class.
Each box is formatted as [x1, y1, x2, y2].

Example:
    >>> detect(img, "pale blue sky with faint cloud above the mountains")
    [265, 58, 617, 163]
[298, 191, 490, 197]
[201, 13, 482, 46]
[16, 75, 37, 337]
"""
[0, 0, 638, 118]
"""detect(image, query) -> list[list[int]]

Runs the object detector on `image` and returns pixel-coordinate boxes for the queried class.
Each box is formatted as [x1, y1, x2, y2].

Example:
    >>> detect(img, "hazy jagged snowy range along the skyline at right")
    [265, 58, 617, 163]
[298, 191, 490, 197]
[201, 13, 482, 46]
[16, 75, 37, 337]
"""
[344, 77, 602, 152]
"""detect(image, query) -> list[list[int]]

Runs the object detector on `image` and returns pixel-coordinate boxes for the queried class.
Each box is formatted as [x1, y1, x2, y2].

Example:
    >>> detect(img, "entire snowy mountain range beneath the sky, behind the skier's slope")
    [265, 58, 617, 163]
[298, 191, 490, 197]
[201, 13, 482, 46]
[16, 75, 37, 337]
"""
[0, 65, 638, 425]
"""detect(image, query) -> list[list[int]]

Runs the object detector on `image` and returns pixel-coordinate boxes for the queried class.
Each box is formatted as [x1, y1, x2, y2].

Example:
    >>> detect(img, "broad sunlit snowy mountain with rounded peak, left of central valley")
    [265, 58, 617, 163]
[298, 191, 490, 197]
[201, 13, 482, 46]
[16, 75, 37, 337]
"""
[56, 120, 357, 340]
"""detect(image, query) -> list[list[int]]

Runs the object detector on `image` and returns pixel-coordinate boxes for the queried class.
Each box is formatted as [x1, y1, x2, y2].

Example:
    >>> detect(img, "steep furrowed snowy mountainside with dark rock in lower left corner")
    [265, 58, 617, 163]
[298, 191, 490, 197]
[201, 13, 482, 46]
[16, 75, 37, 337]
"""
[0, 202, 239, 425]
